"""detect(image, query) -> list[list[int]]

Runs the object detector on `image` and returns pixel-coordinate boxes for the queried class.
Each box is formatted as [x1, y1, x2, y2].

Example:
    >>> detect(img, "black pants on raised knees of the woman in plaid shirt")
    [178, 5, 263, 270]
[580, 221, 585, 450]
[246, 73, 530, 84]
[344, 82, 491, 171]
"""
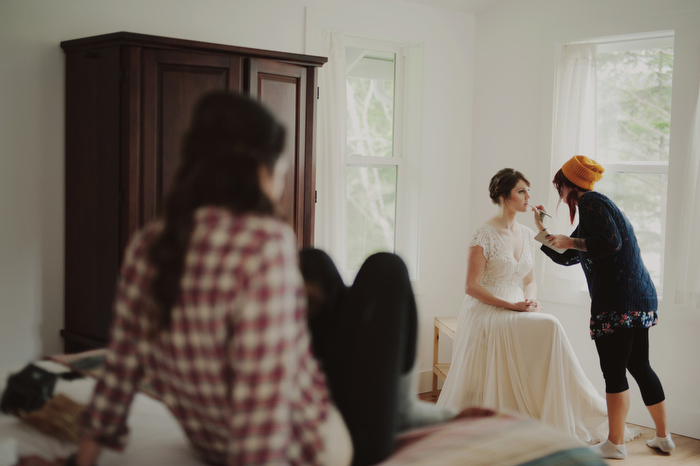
[300, 249, 417, 466]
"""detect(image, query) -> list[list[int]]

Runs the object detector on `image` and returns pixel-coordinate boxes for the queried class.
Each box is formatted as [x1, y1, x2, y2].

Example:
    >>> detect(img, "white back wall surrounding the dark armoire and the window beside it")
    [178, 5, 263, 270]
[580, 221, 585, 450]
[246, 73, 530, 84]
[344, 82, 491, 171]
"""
[0, 0, 474, 390]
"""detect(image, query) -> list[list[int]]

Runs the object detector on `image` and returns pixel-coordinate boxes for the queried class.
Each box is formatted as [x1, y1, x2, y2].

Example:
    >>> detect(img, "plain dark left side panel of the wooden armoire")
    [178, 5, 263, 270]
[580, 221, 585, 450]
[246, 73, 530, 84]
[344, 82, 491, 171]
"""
[65, 47, 120, 350]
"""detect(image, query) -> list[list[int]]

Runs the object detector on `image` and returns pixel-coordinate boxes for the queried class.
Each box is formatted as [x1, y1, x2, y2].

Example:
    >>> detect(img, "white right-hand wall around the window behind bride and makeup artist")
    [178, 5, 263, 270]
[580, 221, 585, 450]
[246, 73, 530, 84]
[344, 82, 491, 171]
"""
[470, 0, 700, 438]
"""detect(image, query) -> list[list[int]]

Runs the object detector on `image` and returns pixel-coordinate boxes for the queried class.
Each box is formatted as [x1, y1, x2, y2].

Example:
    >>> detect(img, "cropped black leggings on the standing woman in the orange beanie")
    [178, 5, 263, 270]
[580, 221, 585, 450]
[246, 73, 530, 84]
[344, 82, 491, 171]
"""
[595, 328, 666, 406]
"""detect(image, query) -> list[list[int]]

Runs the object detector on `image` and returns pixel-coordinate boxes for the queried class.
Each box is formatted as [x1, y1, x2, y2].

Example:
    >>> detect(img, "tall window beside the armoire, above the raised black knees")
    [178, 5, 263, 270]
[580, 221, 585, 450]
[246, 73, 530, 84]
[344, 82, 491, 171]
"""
[345, 38, 417, 279]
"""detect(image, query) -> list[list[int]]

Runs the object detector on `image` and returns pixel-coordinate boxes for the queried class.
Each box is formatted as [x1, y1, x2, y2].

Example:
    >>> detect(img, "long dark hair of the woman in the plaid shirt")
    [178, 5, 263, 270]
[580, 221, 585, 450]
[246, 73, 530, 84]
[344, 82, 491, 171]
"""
[148, 91, 285, 331]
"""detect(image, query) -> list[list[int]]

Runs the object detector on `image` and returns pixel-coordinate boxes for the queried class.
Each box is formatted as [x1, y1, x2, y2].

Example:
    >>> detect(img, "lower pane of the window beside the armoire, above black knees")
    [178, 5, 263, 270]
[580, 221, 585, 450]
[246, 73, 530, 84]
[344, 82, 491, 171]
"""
[347, 166, 397, 271]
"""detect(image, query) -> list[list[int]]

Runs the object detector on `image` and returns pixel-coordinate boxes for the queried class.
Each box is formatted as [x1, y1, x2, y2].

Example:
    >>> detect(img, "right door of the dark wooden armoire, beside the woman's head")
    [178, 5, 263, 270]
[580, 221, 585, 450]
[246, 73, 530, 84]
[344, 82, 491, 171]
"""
[249, 59, 306, 247]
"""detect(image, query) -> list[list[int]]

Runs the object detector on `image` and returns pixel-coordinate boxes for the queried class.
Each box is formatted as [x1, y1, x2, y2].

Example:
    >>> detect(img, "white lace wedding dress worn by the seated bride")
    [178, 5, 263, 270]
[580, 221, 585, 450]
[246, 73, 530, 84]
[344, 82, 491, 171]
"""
[437, 224, 607, 442]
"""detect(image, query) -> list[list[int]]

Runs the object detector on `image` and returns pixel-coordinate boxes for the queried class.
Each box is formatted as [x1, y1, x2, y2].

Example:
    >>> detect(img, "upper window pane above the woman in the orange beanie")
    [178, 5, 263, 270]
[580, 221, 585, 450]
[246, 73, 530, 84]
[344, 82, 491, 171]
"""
[596, 47, 673, 164]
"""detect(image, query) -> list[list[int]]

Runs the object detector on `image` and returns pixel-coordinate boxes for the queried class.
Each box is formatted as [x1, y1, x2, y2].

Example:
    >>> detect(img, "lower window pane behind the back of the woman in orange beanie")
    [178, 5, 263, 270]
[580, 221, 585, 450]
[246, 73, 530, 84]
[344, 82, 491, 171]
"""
[596, 173, 668, 287]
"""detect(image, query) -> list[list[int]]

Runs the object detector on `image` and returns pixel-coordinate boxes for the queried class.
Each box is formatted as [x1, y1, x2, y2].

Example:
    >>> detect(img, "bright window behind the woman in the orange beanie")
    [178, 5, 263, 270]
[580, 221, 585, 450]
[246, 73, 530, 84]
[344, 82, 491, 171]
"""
[596, 36, 673, 289]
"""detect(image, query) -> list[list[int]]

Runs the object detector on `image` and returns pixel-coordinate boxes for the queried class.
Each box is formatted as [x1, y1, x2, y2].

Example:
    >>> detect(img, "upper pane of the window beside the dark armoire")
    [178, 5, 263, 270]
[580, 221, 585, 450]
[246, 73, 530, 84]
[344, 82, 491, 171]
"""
[346, 47, 395, 157]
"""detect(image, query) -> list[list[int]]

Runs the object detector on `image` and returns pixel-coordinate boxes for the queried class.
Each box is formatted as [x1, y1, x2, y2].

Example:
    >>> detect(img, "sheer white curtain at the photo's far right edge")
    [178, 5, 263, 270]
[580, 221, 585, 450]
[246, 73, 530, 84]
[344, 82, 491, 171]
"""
[667, 83, 700, 308]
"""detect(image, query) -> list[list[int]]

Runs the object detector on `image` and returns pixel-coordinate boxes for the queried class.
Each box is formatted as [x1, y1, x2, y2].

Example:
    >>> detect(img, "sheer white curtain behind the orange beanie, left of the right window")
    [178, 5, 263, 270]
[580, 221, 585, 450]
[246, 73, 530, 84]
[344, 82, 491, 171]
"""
[544, 44, 597, 291]
